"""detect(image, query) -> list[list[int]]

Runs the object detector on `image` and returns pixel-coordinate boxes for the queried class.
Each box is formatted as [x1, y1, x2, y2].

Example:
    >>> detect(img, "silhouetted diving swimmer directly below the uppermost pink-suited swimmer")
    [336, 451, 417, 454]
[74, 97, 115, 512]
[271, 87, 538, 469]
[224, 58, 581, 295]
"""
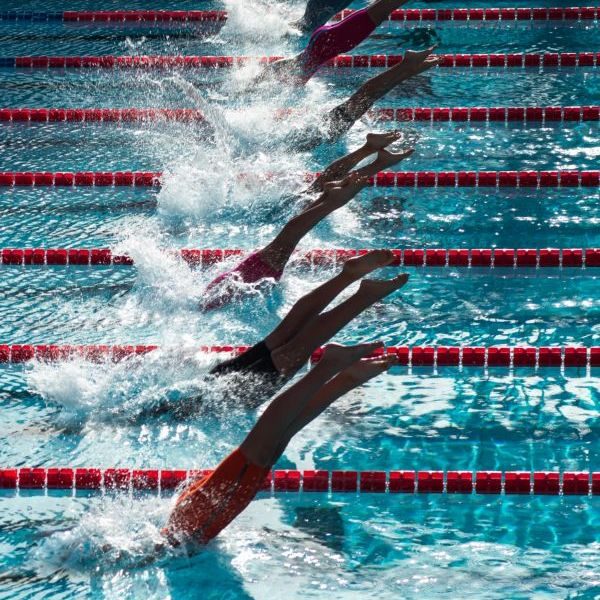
[286, 46, 441, 152]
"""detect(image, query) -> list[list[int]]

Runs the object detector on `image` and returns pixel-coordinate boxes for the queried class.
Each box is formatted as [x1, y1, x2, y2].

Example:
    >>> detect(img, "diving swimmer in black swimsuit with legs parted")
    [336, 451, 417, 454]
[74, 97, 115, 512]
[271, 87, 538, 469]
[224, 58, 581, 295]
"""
[211, 250, 408, 390]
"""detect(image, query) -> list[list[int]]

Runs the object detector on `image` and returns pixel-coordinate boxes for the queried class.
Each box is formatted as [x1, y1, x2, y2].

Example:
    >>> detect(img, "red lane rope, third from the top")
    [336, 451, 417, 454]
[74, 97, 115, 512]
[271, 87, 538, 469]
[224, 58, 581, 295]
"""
[0, 106, 600, 123]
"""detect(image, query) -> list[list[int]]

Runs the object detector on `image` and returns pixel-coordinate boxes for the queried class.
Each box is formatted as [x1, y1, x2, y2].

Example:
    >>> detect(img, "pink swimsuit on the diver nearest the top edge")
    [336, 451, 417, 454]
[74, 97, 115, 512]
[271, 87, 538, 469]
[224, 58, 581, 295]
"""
[302, 8, 375, 80]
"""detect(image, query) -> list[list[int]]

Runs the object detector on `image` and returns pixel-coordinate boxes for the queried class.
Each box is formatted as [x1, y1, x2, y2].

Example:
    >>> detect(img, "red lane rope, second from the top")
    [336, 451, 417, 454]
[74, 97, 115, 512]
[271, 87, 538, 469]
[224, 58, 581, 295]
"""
[8, 52, 600, 69]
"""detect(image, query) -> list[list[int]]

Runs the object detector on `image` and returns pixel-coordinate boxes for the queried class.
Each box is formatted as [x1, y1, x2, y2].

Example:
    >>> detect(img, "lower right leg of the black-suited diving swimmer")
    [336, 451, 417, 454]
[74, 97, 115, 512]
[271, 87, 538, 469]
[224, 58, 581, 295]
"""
[271, 273, 408, 375]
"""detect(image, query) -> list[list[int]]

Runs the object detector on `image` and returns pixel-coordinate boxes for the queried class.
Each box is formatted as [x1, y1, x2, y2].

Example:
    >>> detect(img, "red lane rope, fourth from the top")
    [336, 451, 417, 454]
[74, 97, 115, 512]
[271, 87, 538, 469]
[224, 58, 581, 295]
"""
[0, 170, 600, 188]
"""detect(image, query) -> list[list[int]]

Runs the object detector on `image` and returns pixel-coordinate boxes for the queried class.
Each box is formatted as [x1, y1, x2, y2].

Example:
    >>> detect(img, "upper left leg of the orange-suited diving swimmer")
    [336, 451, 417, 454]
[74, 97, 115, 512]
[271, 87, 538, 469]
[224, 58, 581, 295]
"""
[240, 343, 381, 467]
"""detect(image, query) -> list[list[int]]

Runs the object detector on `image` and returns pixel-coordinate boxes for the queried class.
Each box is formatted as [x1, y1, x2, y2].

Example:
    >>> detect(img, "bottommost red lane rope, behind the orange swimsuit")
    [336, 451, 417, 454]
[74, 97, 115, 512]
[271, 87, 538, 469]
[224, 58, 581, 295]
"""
[0, 467, 600, 496]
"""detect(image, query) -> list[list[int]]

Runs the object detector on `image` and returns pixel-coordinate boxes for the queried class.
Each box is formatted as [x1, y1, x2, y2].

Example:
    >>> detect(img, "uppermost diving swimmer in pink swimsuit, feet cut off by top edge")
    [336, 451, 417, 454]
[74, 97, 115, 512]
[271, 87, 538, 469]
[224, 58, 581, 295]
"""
[254, 0, 408, 84]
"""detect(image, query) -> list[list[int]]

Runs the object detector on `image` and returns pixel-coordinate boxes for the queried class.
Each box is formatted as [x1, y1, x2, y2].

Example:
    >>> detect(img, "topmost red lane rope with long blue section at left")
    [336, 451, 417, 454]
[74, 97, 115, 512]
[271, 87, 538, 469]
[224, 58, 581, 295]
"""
[0, 6, 600, 24]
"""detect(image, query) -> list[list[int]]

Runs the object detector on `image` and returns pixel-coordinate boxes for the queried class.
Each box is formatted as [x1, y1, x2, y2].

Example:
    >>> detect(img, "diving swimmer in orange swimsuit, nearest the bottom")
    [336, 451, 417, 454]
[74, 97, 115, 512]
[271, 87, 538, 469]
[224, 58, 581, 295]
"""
[162, 343, 397, 546]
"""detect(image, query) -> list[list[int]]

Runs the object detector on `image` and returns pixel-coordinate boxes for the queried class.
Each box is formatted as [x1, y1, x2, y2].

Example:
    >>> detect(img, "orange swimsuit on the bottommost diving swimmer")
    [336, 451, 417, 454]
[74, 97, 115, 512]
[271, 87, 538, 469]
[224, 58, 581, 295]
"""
[163, 448, 271, 545]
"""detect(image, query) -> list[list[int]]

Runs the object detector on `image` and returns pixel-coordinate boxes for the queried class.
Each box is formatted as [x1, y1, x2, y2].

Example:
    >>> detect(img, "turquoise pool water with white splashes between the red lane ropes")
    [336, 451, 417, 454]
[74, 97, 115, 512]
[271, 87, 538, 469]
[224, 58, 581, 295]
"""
[0, 0, 600, 599]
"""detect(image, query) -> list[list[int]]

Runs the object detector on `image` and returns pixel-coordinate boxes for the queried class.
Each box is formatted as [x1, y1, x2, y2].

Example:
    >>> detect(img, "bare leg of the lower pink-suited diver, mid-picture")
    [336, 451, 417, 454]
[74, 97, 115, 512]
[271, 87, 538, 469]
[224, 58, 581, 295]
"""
[259, 175, 368, 272]
